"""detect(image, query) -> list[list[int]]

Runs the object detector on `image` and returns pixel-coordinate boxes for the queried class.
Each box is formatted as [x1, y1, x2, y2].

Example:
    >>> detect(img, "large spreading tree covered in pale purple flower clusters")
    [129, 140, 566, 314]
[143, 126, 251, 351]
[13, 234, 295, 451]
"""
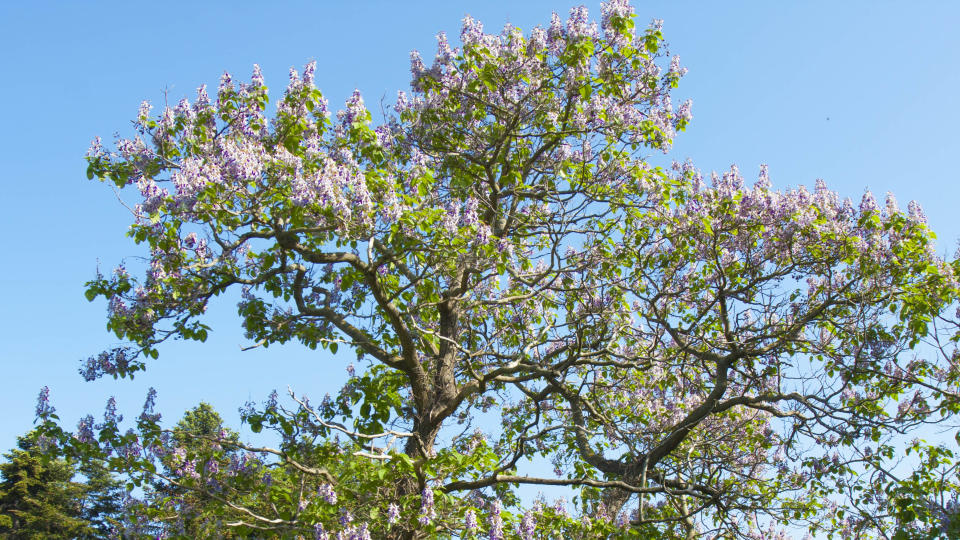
[47, 0, 960, 538]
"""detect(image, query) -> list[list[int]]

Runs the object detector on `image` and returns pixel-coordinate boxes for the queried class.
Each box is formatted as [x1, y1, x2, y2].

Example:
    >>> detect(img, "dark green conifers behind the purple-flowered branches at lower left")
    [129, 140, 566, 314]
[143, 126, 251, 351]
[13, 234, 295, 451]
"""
[0, 403, 236, 540]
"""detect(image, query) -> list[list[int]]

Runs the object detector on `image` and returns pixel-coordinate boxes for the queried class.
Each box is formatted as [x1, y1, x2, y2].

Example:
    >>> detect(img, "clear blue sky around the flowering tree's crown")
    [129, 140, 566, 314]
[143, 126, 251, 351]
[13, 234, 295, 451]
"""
[0, 0, 960, 464]
